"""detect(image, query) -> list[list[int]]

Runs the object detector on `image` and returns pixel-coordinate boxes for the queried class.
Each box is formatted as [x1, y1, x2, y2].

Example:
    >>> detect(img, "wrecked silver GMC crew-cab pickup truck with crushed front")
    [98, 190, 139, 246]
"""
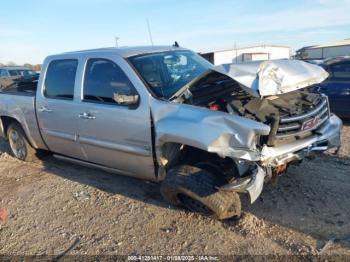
[0, 46, 342, 219]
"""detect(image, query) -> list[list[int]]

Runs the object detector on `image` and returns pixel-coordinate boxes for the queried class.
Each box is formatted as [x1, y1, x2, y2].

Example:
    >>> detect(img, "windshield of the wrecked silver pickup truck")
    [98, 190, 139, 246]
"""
[129, 51, 213, 99]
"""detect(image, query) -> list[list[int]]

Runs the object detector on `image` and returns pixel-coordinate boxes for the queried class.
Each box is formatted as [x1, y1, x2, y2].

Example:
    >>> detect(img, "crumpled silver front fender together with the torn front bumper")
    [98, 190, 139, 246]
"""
[151, 95, 342, 203]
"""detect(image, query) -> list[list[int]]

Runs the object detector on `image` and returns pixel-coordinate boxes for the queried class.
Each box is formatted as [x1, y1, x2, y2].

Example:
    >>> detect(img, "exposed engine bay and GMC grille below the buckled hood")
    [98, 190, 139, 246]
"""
[183, 72, 328, 145]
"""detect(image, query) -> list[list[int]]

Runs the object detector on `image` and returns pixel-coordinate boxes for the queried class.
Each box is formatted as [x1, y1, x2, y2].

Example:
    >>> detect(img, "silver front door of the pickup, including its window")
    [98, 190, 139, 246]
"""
[79, 57, 155, 179]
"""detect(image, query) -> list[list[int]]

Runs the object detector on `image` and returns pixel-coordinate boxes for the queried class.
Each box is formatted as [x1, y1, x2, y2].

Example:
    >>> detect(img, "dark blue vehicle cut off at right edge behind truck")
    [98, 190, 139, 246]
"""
[319, 56, 350, 119]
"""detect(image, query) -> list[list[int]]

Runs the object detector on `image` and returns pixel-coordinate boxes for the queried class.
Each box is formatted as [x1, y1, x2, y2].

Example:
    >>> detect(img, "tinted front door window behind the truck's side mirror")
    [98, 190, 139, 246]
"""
[84, 58, 136, 104]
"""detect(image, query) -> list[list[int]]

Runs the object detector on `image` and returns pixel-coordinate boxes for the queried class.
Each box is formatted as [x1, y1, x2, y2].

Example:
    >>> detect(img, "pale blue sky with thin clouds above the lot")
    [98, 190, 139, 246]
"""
[0, 0, 350, 64]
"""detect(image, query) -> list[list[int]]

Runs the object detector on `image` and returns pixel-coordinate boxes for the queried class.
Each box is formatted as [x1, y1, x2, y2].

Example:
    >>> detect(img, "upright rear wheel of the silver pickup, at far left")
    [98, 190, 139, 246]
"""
[7, 123, 38, 162]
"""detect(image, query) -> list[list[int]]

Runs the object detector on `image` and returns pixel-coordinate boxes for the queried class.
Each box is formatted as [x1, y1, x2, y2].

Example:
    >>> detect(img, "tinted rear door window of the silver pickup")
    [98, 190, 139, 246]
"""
[44, 59, 78, 100]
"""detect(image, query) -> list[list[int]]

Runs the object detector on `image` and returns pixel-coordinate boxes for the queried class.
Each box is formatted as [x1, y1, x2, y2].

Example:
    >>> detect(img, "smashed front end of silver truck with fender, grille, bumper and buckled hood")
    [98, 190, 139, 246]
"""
[151, 60, 342, 205]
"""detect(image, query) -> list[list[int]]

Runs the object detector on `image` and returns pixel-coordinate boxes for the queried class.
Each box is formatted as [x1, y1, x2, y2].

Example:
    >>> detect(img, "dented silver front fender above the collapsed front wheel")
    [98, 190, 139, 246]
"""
[151, 99, 270, 162]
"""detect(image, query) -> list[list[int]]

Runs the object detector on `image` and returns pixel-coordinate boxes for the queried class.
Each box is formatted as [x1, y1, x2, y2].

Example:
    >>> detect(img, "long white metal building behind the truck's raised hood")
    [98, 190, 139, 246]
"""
[200, 45, 290, 65]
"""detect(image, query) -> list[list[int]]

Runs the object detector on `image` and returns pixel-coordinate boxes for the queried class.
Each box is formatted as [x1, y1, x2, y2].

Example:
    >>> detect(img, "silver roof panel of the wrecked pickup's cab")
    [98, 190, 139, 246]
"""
[63, 46, 187, 58]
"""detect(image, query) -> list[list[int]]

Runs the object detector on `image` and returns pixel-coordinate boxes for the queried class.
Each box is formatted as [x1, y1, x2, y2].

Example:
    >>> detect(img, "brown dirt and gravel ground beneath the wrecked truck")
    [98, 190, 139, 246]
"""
[0, 125, 350, 256]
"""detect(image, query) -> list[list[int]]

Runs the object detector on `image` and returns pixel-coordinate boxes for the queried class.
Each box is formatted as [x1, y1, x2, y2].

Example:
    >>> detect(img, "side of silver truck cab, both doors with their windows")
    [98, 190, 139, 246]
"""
[36, 47, 171, 179]
